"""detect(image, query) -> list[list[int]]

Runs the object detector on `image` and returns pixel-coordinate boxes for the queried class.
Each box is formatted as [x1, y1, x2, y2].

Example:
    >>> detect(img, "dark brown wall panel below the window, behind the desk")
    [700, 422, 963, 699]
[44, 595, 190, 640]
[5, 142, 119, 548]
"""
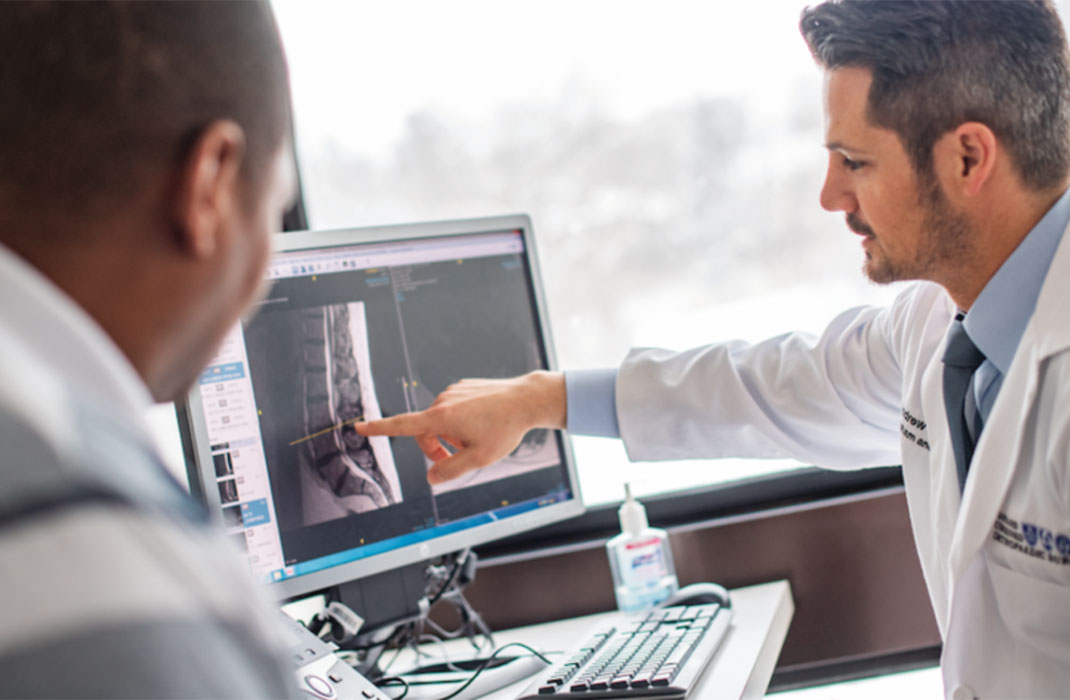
[468, 492, 939, 669]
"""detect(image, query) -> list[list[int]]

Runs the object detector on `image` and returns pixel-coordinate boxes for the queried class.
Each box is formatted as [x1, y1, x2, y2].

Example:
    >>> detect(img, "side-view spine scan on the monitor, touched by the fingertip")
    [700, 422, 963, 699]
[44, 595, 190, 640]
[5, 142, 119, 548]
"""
[245, 302, 402, 529]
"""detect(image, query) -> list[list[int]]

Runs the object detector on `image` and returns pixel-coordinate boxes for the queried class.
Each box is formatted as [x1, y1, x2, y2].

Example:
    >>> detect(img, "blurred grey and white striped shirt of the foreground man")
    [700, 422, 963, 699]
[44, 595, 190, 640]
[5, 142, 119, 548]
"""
[0, 248, 296, 698]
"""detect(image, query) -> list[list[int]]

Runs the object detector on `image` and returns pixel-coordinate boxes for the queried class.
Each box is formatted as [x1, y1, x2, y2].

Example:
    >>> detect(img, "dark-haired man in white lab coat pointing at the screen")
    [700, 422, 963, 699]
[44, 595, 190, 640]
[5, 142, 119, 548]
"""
[362, 0, 1070, 698]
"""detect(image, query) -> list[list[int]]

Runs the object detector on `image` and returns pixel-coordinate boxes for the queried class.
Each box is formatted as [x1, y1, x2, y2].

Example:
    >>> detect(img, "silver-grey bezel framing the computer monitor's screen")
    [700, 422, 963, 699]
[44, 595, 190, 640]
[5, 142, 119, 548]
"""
[177, 214, 584, 600]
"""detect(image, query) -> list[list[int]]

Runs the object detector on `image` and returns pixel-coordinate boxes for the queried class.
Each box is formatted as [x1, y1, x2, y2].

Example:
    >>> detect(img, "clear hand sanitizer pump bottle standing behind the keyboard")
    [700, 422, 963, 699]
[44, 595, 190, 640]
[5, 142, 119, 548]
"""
[606, 484, 677, 612]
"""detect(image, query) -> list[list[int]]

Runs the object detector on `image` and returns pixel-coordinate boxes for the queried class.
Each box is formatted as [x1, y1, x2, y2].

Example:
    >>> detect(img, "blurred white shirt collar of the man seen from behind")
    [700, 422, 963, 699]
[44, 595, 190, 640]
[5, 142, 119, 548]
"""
[0, 245, 152, 435]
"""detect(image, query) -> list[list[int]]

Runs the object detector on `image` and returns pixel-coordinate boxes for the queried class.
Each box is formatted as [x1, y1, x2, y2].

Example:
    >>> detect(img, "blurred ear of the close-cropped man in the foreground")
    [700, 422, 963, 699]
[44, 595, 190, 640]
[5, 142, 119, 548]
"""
[174, 120, 245, 258]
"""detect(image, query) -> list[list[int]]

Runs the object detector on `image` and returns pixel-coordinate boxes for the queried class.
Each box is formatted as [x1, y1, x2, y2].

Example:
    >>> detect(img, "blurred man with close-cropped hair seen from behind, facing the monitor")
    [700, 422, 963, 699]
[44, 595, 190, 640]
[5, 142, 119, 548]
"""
[0, 2, 295, 698]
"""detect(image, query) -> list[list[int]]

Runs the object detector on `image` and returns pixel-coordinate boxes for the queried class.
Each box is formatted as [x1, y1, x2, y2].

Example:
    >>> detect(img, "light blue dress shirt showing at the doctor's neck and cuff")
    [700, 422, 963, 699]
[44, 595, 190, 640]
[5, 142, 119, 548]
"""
[565, 191, 1070, 438]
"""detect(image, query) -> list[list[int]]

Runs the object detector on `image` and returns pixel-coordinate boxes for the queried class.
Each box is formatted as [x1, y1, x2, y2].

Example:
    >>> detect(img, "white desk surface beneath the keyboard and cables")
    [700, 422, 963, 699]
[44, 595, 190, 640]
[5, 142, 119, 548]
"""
[402, 581, 795, 700]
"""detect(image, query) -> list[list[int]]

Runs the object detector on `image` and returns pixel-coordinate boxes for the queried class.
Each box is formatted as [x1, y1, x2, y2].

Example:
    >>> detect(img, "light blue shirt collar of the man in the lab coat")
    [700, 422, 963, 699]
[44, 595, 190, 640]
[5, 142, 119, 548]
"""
[964, 185, 1070, 375]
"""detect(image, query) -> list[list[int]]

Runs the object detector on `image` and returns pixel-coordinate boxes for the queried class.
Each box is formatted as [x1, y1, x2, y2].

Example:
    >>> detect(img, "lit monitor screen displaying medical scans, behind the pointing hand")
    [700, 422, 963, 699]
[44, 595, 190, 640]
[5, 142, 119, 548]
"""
[199, 231, 574, 581]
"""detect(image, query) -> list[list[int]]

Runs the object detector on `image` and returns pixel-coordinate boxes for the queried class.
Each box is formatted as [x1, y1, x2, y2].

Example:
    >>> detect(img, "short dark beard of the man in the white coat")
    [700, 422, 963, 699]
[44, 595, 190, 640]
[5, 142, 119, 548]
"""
[847, 177, 973, 285]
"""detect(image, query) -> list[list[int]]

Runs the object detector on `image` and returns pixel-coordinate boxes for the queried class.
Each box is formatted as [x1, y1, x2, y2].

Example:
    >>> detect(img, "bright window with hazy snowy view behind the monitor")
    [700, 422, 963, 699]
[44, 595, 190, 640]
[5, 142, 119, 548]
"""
[275, 0, 907, 504]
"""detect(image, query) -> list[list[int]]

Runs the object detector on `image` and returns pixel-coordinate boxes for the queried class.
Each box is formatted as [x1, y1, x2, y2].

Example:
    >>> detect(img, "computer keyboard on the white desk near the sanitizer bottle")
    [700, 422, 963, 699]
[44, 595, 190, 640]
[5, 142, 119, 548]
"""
[518, 604, 732, 700]
